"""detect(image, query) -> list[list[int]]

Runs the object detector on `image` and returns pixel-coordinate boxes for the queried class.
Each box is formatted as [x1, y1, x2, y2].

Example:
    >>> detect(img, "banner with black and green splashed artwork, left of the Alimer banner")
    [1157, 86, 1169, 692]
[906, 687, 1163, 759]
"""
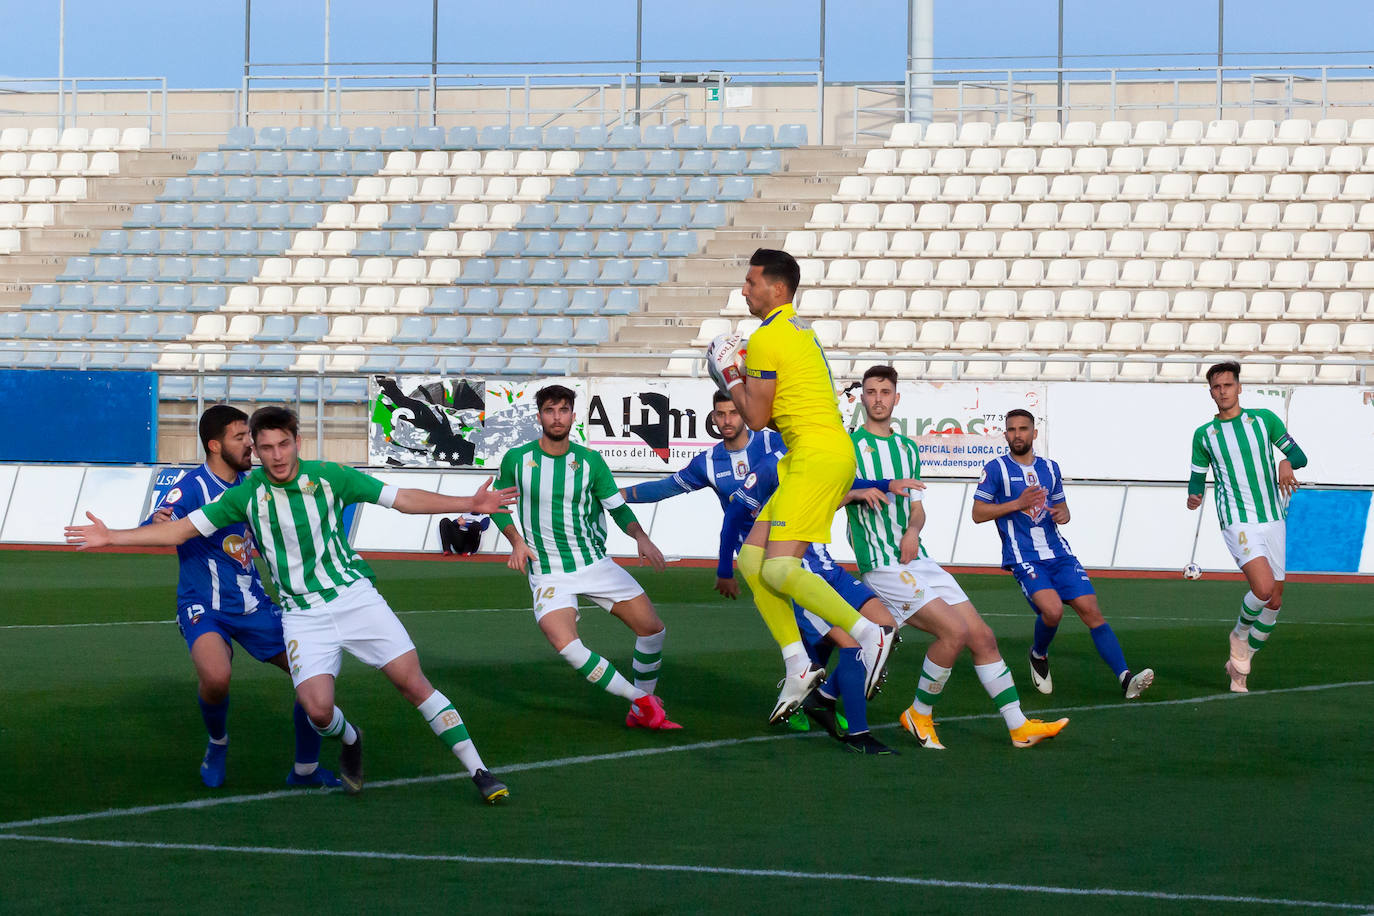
[367, 375, 587, 468]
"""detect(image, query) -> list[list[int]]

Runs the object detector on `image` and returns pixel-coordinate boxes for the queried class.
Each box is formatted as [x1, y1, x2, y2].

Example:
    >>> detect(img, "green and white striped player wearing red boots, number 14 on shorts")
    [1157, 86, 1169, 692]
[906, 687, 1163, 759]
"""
[492, 385, 679, 728]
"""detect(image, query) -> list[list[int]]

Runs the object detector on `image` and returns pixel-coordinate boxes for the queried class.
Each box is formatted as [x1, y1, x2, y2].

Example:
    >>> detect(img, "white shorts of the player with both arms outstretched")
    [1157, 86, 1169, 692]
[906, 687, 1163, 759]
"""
[282, 580, 415, 684]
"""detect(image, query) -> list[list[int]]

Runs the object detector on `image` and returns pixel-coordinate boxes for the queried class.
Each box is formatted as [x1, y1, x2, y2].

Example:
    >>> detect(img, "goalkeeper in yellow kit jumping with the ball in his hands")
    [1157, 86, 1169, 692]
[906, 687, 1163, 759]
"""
[706, 249, 894, 721]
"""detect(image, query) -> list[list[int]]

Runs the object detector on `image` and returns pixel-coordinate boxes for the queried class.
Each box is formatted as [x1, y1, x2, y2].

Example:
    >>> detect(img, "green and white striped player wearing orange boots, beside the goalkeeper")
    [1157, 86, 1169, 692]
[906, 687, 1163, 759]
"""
[845, 365, 1069, 750]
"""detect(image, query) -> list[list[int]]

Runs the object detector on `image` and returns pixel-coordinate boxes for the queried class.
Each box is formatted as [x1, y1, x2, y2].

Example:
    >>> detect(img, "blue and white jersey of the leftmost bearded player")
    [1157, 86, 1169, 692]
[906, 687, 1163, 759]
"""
[144, 464, 272, 614]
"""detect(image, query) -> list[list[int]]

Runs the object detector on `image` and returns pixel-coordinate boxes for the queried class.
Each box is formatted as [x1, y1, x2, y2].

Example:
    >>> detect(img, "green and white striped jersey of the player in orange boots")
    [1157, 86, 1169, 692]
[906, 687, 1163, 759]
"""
[845, 427, 926, 574]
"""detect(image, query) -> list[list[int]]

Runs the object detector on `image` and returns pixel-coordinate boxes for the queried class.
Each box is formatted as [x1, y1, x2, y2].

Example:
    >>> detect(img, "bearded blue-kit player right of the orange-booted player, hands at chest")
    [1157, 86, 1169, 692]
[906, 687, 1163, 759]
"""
[973, 409, 1154, 699]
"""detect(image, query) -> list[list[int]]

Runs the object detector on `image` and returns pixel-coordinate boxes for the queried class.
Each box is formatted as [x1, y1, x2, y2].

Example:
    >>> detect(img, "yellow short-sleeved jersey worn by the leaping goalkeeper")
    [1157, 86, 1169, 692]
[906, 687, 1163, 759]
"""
[745, 302, 853, 453]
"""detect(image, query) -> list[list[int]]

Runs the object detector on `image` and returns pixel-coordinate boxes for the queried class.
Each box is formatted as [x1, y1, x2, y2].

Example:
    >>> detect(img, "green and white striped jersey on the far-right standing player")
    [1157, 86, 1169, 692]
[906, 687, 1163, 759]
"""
[1193, 409, 1293, 527]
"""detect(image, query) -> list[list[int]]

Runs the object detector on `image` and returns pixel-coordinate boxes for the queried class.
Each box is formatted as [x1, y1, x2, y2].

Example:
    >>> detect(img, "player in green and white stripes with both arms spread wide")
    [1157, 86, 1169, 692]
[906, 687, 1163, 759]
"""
[66, 407, 515, 803]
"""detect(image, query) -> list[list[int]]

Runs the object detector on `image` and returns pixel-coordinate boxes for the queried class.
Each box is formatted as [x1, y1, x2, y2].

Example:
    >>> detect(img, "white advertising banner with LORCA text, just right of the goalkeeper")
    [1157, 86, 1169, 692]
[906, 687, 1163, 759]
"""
[840, 380, 1050, 477]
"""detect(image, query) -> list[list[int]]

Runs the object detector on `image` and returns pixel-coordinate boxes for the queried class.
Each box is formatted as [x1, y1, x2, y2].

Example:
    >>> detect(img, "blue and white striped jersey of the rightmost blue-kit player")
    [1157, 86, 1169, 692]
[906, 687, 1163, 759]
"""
[973, 455, 1073, 569]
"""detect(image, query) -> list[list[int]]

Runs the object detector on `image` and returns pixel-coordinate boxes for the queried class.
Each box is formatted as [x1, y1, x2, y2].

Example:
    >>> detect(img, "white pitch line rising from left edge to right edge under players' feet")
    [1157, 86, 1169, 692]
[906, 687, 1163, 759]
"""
[0, 680, 1374, 831]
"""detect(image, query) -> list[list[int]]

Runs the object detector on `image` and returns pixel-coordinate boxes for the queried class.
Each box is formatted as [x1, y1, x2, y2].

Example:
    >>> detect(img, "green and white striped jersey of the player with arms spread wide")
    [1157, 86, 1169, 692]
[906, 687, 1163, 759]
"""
[187, 461, 397, 611]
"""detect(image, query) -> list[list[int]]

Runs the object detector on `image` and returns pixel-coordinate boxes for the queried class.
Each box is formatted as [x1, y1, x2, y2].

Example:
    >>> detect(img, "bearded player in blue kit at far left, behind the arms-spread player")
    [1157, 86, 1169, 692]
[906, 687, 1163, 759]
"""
[144, 404, 339, 788]
